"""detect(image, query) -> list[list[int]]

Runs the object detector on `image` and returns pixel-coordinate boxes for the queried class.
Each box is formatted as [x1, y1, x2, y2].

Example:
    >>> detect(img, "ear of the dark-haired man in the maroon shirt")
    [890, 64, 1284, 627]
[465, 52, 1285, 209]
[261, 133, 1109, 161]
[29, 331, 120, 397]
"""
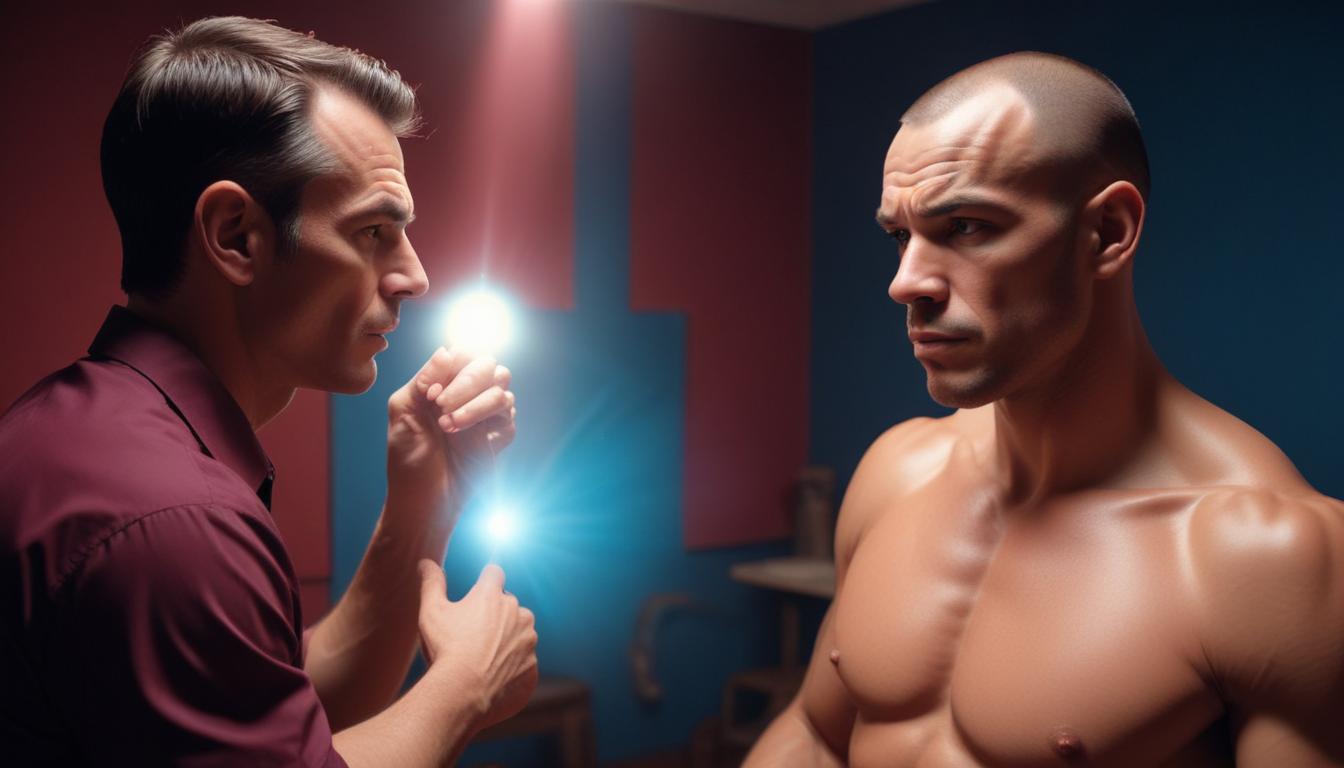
[194, 182, 276, 285]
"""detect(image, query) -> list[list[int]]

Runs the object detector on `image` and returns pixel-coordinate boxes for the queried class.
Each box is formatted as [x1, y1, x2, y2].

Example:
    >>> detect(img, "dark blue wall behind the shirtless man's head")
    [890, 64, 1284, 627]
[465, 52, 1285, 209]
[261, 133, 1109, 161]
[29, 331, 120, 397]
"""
[810, 0, 1344, 496]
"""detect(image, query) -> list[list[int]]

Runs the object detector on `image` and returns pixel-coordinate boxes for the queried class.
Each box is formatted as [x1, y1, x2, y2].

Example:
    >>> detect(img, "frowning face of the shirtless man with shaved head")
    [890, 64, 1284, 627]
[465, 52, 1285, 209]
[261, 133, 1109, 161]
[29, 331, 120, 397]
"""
[878, 86, 1091, 408]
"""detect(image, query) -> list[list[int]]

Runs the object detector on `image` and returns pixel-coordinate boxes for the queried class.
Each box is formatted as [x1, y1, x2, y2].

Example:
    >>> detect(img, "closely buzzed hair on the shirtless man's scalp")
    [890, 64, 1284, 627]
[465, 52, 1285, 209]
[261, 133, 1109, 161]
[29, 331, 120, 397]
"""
[900, 52, 1150, 200]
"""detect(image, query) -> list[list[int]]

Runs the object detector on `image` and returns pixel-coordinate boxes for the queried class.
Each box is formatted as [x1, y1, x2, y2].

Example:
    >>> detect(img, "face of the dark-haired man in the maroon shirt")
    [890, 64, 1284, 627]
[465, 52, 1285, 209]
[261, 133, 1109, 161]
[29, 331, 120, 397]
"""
[242, 87, 427, 393]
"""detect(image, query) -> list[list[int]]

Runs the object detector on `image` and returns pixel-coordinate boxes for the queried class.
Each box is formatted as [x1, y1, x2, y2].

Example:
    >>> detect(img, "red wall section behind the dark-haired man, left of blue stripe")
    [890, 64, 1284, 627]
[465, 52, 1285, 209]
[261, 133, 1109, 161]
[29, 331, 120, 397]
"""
[0, 0, 574, 620]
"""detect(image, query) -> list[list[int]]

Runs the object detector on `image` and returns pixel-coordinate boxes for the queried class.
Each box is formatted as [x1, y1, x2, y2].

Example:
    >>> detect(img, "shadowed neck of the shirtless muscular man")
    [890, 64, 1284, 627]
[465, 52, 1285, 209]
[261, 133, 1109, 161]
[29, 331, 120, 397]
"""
[993, 303, 1169, 507]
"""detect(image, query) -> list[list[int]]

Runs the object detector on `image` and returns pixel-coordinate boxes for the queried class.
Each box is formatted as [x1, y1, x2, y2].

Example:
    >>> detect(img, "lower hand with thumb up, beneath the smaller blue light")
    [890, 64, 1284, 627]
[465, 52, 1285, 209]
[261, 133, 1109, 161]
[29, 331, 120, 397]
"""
[419, 560, 536, 728]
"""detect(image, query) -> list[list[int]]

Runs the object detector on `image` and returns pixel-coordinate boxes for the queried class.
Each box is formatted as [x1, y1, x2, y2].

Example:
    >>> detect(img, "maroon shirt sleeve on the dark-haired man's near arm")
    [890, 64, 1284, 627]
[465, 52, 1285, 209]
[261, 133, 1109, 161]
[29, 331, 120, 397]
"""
[60, 506, 345, 768]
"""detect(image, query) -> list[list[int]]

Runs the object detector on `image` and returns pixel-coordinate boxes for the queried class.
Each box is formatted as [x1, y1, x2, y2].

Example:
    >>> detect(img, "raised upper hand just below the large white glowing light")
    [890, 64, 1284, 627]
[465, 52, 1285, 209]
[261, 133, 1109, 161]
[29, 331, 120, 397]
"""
[387, 347, 517, 510]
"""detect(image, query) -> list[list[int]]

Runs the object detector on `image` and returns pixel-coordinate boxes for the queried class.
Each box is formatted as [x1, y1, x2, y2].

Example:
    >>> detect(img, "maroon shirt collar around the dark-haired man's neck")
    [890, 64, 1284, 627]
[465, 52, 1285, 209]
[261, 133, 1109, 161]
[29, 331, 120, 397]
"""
[126, 296, 294, 432]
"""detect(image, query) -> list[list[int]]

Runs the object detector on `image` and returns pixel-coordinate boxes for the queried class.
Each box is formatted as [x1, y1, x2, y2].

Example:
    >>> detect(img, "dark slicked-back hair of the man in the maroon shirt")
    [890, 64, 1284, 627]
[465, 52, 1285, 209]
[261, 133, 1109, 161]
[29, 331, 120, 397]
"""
[101, 16, 419, 299]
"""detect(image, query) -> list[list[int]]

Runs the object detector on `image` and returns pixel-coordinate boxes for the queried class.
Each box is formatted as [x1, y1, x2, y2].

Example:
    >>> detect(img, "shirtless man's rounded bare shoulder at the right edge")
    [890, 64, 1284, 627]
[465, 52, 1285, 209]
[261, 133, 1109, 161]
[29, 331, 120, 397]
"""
[1188, 483, 1344, 703]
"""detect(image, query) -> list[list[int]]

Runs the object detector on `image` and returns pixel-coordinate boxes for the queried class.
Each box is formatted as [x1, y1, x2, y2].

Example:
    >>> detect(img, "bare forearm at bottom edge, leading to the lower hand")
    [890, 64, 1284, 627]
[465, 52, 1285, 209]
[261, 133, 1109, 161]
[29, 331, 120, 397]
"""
[333, 667, 487, 768]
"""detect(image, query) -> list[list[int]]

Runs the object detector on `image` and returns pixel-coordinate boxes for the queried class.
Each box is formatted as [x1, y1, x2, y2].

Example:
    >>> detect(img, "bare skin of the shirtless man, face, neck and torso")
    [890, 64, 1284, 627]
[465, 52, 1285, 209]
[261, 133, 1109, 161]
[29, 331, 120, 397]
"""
[746, 57, 1344, 768]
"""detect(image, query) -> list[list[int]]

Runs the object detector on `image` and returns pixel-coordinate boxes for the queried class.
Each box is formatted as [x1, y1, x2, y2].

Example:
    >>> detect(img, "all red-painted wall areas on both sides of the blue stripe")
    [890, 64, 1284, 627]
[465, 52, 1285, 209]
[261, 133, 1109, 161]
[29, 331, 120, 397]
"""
[0, 0, 810, 619]
